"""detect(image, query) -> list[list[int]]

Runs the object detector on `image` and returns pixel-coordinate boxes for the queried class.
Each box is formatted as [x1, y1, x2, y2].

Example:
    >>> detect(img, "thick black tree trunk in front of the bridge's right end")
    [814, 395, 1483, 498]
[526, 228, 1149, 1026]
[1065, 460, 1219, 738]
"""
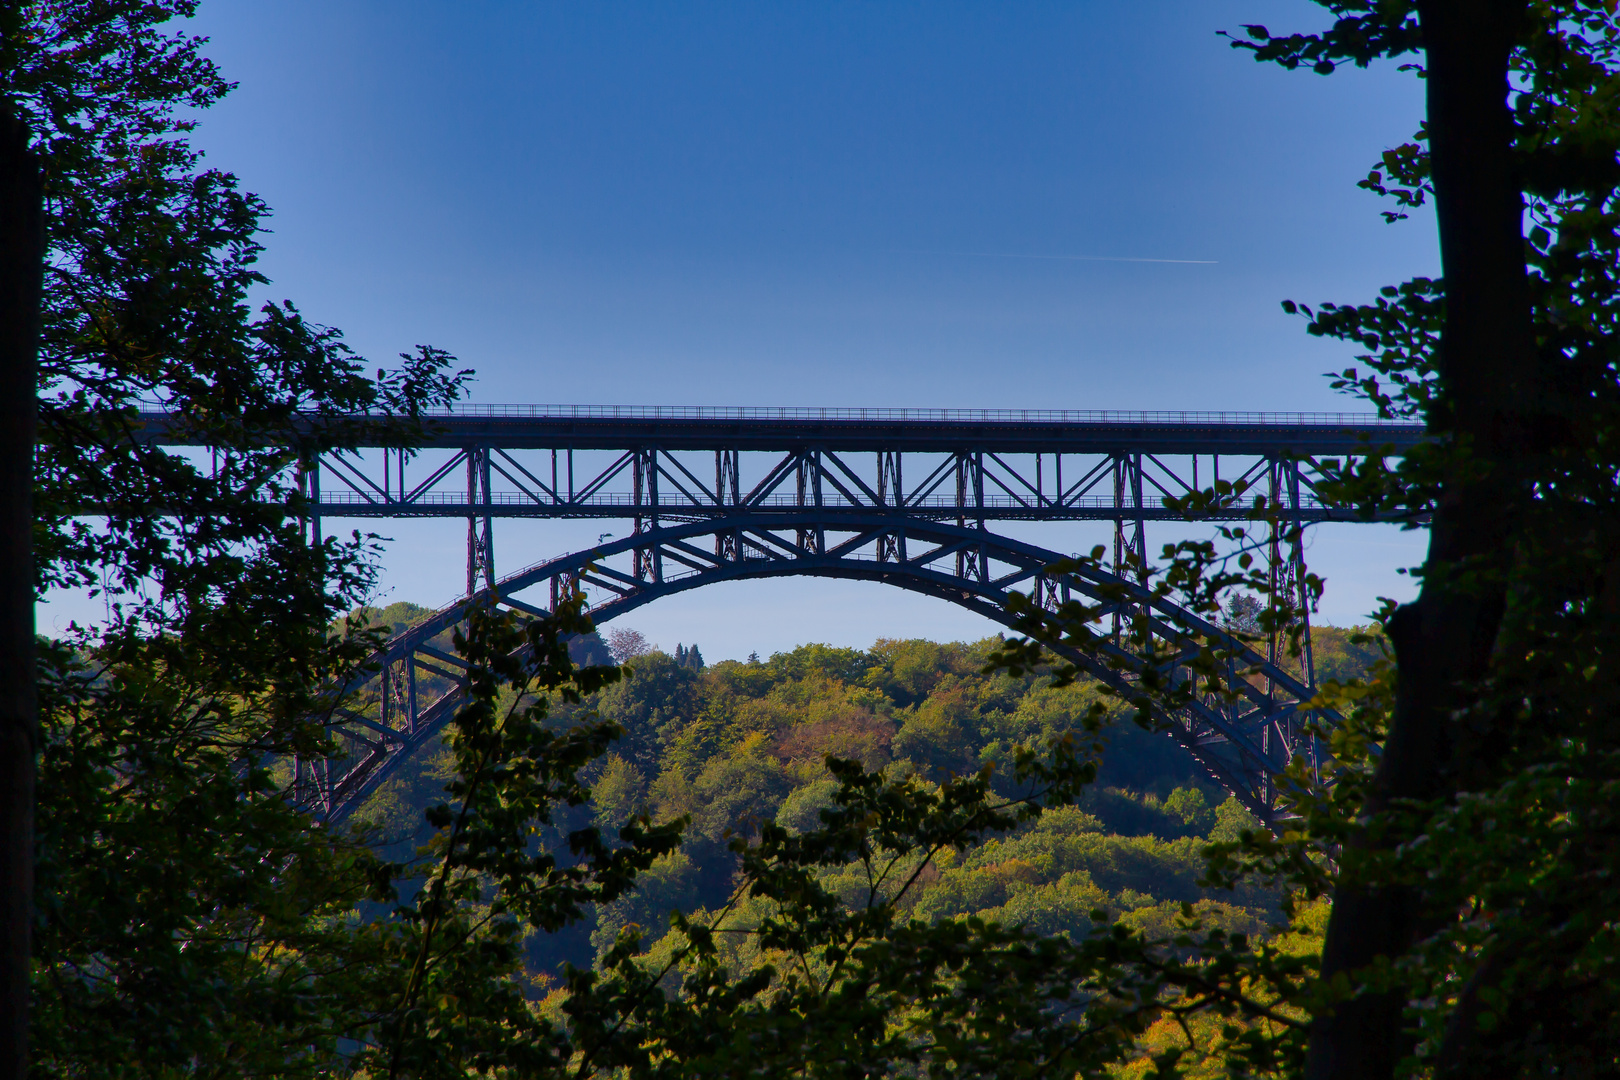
[1307, 0, 1537, 1080]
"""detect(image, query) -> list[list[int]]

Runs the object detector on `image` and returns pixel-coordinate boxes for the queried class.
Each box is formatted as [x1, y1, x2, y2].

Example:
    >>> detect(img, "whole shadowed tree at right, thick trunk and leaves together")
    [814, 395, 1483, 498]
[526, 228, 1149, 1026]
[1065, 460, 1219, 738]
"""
[972, 0, 1620, 1078]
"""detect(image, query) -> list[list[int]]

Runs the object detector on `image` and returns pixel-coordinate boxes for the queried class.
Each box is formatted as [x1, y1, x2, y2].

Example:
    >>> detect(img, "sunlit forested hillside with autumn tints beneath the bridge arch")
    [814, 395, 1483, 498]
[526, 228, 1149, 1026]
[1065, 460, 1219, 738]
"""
[360, 604, 1379, 975]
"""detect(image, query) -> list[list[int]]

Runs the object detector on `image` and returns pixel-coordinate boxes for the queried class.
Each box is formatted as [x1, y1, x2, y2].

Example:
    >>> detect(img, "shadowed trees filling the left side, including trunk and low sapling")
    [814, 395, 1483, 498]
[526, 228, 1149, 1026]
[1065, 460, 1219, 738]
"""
[0, 0, 690, 1077]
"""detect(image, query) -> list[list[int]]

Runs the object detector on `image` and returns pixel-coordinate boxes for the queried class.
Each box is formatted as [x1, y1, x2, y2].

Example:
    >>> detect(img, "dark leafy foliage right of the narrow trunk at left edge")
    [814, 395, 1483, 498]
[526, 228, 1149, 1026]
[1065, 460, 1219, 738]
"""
[17, 0, 467, 1077]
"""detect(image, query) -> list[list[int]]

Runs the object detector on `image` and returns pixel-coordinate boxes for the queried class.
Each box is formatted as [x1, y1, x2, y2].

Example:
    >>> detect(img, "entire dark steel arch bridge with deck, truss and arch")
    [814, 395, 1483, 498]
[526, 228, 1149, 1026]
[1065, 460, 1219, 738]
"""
[147, 405, 1422, 823]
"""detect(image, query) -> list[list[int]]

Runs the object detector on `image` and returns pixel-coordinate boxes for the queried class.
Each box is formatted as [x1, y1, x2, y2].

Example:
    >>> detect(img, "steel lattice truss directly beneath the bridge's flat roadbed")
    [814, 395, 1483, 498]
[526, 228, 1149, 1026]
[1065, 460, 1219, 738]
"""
[298, 440, 1412, 524]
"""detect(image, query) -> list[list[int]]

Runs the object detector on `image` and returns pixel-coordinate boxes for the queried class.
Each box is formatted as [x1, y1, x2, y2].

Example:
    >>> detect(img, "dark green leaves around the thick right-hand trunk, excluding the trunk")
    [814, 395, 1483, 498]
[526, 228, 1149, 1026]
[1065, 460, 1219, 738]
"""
[1218, 2, 1620, 1075]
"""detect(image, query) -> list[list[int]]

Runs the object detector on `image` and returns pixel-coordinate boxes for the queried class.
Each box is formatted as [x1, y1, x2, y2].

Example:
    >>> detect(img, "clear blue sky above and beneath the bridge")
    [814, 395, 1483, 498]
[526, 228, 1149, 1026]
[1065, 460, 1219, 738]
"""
[38, 0, 1437, 659]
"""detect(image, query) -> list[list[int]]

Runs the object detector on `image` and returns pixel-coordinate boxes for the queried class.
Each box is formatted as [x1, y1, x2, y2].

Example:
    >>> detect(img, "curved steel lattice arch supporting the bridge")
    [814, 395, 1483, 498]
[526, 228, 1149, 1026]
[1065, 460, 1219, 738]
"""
[312, 507, 1315, 823]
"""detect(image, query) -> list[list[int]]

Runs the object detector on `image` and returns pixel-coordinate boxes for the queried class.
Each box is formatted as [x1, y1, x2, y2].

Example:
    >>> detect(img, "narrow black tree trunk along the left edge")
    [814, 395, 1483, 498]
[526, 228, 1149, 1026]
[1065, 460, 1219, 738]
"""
[0, 105, 44, 1080]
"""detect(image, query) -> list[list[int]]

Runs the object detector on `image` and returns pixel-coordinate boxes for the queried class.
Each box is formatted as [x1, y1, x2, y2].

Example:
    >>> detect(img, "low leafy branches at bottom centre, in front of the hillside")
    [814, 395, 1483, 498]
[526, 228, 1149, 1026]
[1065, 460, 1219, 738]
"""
[544, 722, 1312, 1077]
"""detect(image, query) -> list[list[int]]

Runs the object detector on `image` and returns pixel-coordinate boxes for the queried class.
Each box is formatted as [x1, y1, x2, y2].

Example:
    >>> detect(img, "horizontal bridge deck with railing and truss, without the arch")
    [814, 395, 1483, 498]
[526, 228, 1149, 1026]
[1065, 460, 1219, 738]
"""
[143, 405, 1424, 524]
